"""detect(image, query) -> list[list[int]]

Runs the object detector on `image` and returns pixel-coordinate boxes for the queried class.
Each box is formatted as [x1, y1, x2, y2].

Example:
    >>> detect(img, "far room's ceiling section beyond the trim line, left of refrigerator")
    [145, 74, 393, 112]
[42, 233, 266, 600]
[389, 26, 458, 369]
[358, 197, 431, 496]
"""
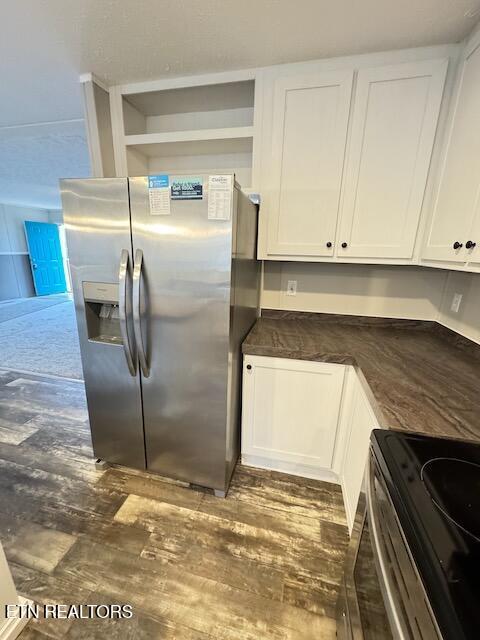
[0, 121, 90, 209]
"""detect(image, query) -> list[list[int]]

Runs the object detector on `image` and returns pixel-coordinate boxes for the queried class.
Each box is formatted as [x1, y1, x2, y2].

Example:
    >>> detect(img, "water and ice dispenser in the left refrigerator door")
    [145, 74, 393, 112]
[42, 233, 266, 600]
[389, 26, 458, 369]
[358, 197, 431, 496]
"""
[83, 282, 123, 344]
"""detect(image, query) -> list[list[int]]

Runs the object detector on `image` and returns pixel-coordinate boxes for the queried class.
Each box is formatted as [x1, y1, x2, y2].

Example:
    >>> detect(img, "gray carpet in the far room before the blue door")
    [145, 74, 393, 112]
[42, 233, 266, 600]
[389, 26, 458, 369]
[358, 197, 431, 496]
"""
[0, 296, 83, 380]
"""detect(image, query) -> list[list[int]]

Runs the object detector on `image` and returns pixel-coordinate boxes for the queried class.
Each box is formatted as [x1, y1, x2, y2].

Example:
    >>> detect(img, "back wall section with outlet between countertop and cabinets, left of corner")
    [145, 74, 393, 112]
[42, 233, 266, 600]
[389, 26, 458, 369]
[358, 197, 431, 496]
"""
[261, 262, 447, 320]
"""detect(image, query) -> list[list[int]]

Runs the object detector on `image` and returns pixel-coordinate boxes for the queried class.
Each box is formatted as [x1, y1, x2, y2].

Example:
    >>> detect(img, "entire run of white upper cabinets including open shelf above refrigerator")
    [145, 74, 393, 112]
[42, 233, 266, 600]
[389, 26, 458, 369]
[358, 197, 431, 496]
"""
[85, 43, 462, 271]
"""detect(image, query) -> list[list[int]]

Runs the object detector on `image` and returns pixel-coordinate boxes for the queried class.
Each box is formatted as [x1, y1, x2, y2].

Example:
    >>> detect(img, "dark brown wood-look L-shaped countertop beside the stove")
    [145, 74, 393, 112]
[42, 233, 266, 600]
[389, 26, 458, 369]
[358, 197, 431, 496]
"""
[243, 311, 480, 441]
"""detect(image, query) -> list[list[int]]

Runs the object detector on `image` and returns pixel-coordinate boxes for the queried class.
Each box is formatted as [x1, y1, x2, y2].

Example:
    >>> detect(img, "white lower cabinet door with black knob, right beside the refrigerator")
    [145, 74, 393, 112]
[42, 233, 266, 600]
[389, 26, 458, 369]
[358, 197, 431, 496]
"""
[242, 356, 345, 478]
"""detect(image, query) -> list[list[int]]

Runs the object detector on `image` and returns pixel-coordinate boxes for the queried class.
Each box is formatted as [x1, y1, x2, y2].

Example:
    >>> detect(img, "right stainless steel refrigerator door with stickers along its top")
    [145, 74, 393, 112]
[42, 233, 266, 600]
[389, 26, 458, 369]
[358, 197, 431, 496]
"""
[129, 176, 233, 491]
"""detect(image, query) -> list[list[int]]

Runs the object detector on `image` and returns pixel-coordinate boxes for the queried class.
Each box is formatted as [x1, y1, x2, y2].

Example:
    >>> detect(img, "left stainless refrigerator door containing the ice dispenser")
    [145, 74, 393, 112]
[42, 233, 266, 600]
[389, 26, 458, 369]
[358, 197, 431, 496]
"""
[61, 178, 145, 469]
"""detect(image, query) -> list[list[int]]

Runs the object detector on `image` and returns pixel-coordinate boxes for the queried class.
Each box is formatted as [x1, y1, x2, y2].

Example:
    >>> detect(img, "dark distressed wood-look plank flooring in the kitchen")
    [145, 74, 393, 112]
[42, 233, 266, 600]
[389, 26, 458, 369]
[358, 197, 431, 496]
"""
[0, 371, 347, 640]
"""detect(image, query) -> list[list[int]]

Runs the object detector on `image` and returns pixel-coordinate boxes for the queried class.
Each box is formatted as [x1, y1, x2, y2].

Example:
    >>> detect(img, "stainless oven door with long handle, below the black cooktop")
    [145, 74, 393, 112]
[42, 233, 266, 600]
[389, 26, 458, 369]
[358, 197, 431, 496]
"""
[337, 451, 441, 640]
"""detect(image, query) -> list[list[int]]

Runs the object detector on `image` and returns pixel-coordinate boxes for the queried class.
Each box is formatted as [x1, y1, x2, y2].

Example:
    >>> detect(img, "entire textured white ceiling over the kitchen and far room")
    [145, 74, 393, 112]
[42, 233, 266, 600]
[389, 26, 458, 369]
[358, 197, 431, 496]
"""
[0, 0, 480, 206]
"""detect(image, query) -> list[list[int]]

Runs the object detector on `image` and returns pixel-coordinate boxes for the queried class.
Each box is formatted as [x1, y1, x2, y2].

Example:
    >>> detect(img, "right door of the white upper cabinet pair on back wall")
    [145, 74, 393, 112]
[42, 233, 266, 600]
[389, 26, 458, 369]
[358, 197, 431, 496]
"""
[336, 60, 448, 259]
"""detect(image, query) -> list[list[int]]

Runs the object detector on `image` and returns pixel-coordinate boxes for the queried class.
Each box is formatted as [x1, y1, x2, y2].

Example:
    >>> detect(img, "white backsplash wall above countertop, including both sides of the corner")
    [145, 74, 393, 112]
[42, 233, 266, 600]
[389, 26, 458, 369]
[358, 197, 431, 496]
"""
[261, 262, 480, 344]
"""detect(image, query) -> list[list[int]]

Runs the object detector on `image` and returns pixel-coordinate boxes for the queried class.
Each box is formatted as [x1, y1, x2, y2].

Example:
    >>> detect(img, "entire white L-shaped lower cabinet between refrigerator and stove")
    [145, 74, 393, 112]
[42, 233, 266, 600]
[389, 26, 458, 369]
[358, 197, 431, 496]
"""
[241, 355, 379, 532]
